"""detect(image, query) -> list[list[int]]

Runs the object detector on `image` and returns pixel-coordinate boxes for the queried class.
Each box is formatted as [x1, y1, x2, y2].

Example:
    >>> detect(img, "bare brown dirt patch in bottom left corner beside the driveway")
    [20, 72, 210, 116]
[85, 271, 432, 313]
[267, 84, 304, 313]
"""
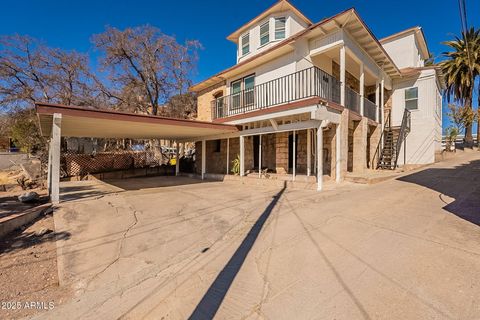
[0, 214, 71, 319]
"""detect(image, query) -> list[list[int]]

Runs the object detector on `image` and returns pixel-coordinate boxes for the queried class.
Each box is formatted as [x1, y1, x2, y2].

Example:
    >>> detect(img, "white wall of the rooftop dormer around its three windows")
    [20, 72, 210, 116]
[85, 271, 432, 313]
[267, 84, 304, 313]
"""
[237, 11, 307, 63]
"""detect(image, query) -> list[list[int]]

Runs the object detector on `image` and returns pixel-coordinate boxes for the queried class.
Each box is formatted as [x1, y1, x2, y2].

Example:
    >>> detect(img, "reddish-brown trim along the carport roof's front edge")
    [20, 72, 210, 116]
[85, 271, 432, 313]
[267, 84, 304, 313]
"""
[35, 103, 239, 131]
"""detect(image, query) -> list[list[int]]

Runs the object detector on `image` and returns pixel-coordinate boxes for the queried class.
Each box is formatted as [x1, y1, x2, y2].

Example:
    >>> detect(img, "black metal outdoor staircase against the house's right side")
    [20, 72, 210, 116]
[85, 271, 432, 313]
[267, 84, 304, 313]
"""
[377, 109, 411, 170]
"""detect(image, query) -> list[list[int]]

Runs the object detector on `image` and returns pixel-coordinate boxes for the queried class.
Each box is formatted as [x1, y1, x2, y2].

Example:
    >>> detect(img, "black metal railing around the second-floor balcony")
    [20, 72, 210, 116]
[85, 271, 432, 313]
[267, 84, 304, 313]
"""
[211, 67, 375, 120]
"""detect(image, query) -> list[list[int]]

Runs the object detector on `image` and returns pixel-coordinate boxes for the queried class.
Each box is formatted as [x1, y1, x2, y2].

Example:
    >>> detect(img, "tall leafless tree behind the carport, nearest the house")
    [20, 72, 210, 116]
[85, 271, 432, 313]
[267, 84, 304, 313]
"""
[93, 26, 200, 115]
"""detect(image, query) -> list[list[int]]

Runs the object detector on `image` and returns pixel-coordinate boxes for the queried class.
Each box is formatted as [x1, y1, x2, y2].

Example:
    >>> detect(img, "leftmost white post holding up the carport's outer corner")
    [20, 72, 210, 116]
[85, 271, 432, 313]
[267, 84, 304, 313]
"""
[50, 113, 62, 204]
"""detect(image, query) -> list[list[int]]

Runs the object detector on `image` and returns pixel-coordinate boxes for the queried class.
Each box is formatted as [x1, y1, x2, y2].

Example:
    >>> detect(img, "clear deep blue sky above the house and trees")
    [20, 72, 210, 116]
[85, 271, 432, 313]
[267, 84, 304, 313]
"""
[0, 0, 480, 130]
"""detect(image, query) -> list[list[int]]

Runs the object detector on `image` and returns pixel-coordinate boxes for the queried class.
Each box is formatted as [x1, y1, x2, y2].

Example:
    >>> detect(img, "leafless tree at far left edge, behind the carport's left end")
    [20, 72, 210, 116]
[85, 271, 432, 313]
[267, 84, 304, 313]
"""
[0, 35, 100, 110]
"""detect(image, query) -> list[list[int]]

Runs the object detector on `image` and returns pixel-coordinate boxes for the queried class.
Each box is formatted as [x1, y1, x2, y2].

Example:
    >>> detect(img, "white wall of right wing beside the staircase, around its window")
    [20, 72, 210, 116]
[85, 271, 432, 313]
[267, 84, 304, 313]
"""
[392, 70, 442, 165]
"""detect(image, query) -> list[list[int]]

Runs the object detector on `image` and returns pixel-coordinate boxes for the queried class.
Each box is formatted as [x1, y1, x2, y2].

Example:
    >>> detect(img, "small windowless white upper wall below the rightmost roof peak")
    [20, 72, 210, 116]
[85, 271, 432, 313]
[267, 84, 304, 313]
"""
[383, 33, 423, 69]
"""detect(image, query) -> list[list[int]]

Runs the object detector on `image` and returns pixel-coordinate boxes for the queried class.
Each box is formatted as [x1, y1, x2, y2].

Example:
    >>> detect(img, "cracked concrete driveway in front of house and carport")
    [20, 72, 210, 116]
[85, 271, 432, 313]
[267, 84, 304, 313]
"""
[35, 153, 480, 320]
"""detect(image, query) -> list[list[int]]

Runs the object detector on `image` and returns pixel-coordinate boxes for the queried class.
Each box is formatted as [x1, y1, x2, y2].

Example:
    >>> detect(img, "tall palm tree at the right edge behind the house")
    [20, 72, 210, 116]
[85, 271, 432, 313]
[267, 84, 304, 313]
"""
[440, 28, 480, 146]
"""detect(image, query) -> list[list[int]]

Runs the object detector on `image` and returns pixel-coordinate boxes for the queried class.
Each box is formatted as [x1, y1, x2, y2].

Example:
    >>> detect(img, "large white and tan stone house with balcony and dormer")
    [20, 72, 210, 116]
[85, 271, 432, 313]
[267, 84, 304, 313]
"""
[191, 0, 442, 190]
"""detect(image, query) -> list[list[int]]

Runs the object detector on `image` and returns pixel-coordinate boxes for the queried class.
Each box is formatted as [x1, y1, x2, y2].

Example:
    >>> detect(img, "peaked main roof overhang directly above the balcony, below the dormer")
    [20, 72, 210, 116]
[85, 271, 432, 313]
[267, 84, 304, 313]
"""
[190, 8, 401, 92]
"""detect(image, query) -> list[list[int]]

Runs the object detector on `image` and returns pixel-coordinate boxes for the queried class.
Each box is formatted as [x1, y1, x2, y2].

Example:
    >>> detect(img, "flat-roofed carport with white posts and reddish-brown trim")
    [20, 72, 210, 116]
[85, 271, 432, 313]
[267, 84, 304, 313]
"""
[36, 103, 239, 203]
